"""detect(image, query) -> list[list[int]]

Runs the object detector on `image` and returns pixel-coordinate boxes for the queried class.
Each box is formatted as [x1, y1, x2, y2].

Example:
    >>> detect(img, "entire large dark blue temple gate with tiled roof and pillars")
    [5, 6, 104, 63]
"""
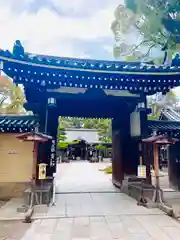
[0, 44, 180, 191]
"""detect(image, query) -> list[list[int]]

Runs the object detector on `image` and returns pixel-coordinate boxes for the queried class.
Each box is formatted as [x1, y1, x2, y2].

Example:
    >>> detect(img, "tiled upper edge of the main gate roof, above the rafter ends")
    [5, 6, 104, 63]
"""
[0, 50, 180, 75]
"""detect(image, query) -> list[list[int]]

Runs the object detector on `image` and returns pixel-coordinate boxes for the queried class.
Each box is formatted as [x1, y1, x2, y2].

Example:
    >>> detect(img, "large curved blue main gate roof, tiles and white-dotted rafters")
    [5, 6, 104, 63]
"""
[0, 47, 180, 95]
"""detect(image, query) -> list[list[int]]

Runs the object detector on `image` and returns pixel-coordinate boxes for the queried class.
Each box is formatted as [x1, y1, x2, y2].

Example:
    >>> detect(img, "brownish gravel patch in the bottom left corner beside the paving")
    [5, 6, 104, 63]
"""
[0, 221, 31, 240]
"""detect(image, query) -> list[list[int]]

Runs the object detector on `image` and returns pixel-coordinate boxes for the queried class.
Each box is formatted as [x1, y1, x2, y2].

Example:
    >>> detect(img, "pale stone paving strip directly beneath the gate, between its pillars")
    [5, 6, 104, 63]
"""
[44, 193, 163, 218]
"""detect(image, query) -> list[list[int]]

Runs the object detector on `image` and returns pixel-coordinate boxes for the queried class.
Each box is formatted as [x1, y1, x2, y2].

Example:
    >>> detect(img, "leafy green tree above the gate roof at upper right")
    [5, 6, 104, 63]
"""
[111, 0, 180, 62]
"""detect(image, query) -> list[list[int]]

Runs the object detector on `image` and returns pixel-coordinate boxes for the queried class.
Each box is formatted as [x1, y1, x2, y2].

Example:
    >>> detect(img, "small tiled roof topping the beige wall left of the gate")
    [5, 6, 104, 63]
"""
[0, 115, 38, 133]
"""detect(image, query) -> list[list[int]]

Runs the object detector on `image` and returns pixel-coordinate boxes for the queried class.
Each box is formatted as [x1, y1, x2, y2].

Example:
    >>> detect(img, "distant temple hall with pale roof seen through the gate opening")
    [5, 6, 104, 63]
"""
[57, 128, 112, 161]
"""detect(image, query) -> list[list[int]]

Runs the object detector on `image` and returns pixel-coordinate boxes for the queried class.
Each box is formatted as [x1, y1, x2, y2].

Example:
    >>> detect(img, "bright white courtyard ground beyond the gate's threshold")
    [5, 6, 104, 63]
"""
[56, 161, 116, 193]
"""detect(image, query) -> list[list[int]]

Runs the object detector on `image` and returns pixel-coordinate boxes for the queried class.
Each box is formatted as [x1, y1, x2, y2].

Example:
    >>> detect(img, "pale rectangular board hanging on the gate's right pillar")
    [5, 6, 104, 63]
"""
[130, 112, 141, 137]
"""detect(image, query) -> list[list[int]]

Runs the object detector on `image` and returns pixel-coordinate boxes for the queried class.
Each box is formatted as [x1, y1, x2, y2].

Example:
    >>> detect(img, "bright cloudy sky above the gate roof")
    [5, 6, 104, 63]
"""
[0, 0, 180, 95]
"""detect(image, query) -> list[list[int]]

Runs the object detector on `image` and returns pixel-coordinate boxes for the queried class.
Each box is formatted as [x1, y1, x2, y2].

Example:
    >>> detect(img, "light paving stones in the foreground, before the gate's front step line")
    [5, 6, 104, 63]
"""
[21, 215, 180, 240]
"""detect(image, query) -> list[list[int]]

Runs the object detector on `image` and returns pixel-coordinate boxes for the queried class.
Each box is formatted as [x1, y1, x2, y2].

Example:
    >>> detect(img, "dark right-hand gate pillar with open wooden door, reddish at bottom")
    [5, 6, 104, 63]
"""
[112, 112, 139, 186]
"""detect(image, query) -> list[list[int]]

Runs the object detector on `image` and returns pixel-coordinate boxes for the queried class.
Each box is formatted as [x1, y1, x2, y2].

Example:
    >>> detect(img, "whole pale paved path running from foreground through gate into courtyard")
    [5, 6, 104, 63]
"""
[21, 163, 180, 240]
